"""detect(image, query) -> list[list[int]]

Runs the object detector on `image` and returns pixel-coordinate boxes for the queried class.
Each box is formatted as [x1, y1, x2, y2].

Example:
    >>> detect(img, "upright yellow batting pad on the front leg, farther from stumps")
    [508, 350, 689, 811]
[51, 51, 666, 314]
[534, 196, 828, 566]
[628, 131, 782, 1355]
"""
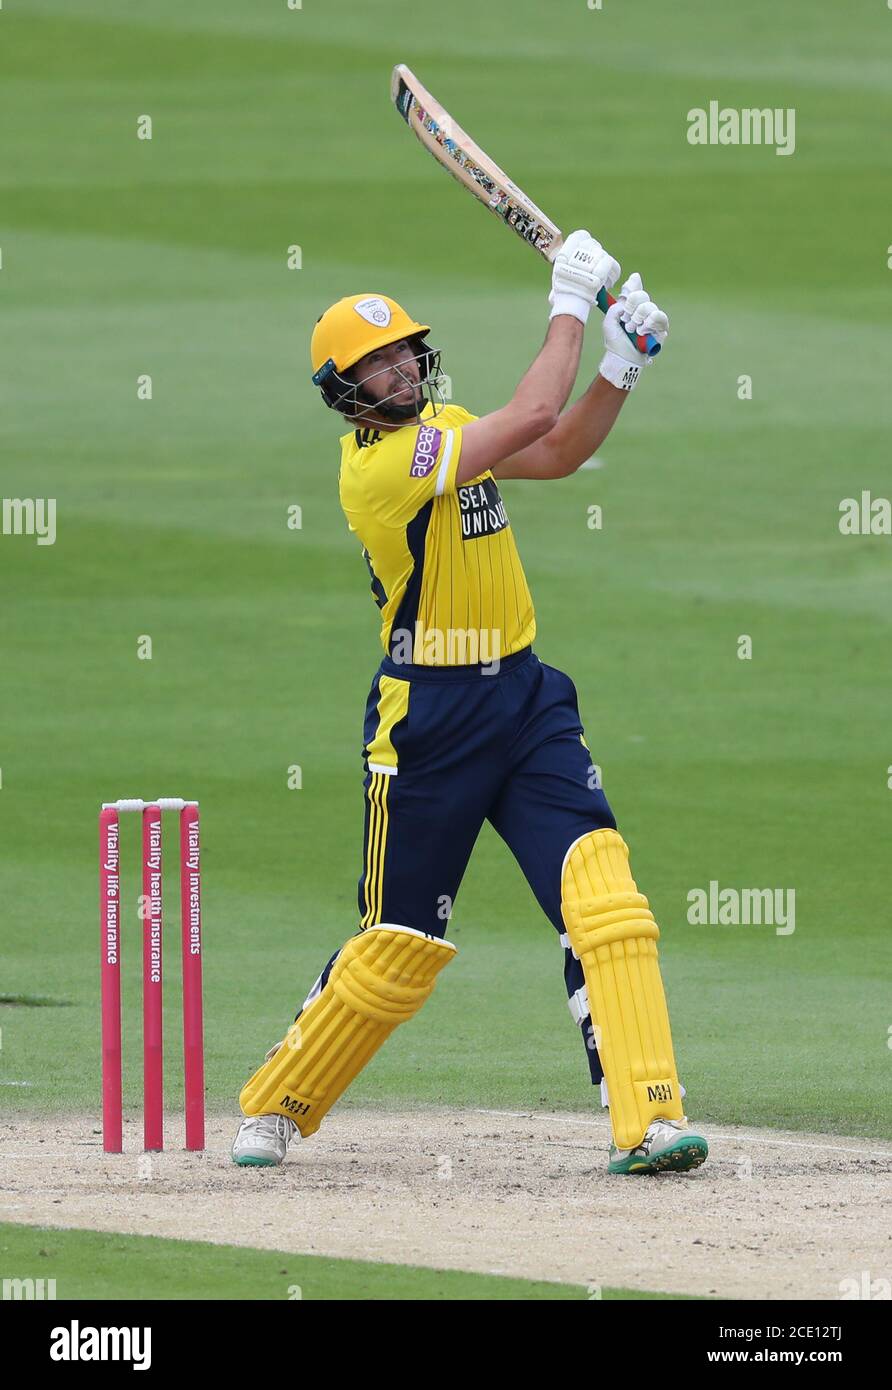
[561, 830, 684, 1148]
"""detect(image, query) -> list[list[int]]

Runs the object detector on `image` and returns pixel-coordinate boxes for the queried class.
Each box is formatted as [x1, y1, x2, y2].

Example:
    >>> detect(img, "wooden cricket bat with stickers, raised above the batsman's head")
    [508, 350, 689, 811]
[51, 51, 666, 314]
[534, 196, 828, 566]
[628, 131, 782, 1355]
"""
[390, 63, 660, 357]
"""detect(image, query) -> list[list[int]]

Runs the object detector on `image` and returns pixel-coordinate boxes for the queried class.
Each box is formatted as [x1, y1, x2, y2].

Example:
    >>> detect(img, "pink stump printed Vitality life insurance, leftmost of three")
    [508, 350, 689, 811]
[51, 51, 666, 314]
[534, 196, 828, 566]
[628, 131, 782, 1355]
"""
[99, 809, 124, 1154]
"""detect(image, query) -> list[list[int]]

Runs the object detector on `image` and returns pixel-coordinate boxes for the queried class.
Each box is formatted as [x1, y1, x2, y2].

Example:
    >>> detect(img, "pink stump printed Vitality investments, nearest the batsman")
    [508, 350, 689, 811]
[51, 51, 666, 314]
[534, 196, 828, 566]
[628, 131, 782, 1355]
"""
[179, 803, 204, 1148]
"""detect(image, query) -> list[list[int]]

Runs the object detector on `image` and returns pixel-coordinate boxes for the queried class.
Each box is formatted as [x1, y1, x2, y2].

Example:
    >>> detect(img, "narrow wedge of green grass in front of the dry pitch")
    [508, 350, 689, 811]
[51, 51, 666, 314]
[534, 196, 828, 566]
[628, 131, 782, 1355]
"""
[0, 1222, 685, 1302]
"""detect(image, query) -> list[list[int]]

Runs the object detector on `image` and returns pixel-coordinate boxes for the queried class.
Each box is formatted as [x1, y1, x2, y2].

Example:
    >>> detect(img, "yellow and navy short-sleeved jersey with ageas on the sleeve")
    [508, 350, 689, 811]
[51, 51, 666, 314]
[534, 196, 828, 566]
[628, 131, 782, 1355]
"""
[334, 403, 536, 666]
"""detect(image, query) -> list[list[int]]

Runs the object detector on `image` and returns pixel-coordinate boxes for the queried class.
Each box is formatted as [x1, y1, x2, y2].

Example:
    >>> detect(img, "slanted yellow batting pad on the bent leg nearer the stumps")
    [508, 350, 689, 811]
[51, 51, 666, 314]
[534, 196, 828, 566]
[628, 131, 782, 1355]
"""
[239, 926, 456, 1138]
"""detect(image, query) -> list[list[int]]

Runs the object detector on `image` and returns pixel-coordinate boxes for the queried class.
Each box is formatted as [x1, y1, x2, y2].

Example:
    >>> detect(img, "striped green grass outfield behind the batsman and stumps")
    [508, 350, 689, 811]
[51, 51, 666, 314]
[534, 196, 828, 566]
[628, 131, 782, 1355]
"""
[0, 0, 892, 1150]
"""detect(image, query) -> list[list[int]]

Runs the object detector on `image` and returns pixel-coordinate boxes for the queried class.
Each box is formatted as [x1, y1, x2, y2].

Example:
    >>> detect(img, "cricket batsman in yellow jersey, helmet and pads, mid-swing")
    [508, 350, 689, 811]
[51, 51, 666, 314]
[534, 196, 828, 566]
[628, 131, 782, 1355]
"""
[232, 231, 707, 1173]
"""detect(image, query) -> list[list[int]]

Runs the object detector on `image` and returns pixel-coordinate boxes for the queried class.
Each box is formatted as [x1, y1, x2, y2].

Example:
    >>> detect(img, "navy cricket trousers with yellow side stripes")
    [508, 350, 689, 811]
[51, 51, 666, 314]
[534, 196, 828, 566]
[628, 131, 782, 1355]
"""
[304, 648, 616, 1083]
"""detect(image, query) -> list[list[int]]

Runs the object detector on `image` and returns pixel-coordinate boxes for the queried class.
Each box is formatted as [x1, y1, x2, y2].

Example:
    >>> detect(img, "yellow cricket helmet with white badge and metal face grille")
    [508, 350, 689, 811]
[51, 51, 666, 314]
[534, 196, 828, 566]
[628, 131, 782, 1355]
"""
[310, 295, 439, 416]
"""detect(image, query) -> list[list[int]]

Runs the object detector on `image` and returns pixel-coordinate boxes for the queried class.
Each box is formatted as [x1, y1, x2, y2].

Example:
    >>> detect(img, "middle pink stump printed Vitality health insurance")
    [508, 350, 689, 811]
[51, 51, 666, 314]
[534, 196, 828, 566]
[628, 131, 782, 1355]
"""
[142, 806, 164, 1151]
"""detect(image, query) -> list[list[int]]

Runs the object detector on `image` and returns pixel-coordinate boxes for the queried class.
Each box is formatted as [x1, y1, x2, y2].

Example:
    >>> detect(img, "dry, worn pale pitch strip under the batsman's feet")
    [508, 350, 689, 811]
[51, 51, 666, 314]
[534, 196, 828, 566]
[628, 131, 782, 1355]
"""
[0, 1109, 892, 1300]
